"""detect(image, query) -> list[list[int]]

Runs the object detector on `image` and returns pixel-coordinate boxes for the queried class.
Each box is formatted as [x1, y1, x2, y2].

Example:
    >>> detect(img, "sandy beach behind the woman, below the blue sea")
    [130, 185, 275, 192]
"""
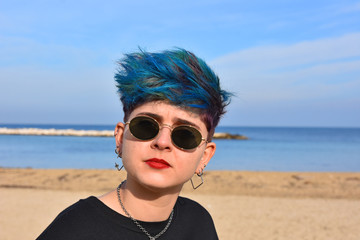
[0, 168, 360, 240]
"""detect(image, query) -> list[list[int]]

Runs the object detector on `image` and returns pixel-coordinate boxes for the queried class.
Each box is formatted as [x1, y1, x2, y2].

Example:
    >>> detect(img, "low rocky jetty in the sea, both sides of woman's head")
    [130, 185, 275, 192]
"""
[0, 128, 248, 140]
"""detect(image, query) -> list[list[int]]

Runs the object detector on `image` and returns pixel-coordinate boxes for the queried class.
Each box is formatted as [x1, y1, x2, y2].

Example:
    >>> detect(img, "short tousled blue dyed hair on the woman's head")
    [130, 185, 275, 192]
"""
[115, 49, 231, 139]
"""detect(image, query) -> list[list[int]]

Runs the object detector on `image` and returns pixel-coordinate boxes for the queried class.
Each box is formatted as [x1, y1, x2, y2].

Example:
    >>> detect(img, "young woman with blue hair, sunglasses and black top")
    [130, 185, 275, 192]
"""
[38, 49, 230, 240]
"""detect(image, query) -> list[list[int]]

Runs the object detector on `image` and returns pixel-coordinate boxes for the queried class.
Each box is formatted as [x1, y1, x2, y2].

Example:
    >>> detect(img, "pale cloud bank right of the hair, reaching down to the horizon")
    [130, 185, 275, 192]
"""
[211, 33, 360, 126]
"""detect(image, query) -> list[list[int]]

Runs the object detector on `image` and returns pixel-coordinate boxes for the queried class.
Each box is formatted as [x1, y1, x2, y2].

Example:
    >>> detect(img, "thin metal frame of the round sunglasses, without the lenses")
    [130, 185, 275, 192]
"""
[125, 115, 209, 151]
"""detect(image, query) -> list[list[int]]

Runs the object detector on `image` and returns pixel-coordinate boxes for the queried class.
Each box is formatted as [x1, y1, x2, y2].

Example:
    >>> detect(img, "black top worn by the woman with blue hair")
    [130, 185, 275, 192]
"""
[37, 196, 218, 240]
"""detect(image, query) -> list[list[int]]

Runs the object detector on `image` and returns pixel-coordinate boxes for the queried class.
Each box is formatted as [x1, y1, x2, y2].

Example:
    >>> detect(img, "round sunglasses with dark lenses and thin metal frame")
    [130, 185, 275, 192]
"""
[125, 116, 207, 150]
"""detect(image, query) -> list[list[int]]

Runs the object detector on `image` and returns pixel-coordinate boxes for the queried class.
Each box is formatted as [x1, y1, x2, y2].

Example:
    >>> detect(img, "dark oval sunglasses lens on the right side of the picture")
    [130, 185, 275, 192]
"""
[171, 126, 201, 149]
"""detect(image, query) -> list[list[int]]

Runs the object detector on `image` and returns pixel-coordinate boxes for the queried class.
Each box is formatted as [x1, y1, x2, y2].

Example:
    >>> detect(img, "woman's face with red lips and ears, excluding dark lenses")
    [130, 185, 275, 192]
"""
[115, 101, 216, 189]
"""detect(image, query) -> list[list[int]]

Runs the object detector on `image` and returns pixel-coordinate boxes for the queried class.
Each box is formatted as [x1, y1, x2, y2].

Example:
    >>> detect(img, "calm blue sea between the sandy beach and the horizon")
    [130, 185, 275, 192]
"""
[0, 124, 360, 172]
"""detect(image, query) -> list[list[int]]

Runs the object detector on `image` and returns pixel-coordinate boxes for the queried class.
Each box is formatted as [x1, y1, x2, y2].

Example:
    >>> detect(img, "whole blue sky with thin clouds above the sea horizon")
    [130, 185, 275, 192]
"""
[0, 0, 360, 127]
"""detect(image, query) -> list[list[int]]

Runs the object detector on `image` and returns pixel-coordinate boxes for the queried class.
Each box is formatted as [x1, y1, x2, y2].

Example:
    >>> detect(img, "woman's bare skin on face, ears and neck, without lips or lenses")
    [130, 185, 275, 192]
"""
[99, 101, 216, 221]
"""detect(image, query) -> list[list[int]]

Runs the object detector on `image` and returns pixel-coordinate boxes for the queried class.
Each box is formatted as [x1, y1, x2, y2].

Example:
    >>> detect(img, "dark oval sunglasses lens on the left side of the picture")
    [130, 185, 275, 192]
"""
[129, 117, 159, 140]
